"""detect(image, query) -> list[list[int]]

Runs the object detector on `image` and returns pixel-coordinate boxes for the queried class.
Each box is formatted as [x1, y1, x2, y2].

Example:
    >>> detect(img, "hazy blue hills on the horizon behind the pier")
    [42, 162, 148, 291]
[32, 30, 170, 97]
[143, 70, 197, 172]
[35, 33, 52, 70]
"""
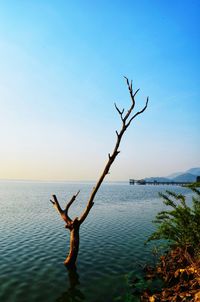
[145, 168, 200, 182]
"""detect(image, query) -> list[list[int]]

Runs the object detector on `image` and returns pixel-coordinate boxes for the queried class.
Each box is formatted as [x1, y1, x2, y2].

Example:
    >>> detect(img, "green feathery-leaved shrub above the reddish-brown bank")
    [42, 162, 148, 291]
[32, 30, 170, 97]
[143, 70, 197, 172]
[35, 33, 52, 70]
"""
[148, 187, 200, 252]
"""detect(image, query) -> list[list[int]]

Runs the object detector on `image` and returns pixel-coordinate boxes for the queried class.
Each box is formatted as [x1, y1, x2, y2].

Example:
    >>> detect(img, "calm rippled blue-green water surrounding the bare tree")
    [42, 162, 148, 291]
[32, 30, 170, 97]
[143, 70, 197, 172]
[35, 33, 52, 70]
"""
[0, 181, 189, 302]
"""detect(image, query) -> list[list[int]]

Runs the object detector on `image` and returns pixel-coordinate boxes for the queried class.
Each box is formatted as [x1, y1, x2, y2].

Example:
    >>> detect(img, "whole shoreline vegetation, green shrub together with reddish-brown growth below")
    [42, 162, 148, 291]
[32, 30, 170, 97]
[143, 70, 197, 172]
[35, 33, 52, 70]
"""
[138, 184, 200, 302]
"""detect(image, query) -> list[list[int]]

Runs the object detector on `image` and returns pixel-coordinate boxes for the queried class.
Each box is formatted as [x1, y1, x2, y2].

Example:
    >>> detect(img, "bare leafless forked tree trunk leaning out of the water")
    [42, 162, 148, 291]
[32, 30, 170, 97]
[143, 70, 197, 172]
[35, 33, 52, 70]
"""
[50, 77, 148, 268]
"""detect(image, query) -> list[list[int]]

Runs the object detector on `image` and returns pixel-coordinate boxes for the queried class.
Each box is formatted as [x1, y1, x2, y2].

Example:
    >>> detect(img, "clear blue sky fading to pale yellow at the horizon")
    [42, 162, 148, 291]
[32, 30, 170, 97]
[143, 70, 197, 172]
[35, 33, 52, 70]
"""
[0, 0, 200, 180]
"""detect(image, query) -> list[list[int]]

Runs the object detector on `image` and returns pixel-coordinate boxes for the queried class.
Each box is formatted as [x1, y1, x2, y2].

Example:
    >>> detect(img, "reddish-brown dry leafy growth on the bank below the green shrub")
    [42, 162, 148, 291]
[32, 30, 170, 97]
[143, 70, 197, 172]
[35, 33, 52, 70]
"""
[141, 247, 200, 302]
